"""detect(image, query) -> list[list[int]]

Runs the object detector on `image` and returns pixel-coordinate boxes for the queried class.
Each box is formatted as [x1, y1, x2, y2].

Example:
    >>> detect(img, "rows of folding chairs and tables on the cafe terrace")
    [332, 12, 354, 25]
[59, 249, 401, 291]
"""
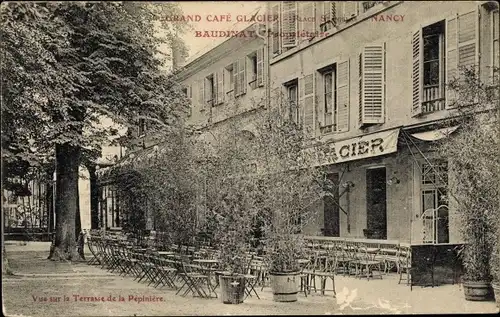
[87, 231, 434, 299]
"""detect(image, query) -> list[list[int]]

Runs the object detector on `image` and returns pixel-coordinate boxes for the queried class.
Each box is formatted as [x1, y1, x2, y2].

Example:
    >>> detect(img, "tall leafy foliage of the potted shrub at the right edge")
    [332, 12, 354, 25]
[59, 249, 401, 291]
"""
[437, 69, 500, 281]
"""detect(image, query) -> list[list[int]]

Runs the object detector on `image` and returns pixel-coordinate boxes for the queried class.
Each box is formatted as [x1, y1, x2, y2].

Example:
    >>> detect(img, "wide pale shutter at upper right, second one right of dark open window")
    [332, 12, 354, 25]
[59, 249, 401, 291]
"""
[458, 10, 479, 78]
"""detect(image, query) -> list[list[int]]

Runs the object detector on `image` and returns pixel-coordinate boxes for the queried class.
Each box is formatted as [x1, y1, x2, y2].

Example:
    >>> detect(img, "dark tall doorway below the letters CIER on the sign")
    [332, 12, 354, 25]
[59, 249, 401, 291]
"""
[365, 167, 387, 239]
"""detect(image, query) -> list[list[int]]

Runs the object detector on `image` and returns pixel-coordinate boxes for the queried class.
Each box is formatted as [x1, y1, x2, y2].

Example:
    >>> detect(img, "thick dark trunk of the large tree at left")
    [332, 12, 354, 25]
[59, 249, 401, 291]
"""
[49, 143, 82, 261]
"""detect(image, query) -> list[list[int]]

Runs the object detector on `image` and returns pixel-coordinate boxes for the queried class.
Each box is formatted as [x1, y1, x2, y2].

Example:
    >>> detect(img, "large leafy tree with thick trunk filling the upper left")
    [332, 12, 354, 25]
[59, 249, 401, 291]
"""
[0, 2, 188, 258]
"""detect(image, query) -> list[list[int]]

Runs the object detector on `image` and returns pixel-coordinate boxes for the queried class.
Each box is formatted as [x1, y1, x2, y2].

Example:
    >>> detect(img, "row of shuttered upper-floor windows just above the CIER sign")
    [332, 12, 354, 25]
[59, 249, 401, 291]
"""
[283, 9, 500, 135]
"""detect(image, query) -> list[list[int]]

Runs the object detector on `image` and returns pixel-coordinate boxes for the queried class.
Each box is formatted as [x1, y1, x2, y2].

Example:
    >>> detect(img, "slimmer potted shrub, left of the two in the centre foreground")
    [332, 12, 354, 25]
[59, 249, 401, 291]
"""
[200, 125, 257, 304]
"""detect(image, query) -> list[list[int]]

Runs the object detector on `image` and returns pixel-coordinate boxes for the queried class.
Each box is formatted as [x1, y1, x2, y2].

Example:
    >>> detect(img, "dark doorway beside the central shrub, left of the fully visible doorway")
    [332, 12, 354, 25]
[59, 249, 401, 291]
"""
[324, 173, 340, 237]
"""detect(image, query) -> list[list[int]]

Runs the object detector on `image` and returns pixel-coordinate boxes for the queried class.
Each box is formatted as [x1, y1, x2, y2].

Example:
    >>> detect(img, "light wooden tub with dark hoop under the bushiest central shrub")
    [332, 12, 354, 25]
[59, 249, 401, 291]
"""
[269, 272, 300, 302]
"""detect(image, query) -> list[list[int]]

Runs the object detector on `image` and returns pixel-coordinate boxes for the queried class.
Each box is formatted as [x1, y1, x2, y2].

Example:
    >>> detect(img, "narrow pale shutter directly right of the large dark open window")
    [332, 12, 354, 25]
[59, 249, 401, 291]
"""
[445, 14, 458, 108]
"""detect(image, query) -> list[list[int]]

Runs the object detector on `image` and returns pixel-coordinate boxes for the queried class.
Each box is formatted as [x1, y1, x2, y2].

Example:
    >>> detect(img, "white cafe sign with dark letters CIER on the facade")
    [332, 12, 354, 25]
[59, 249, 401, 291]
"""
[307, 129, 399, 166]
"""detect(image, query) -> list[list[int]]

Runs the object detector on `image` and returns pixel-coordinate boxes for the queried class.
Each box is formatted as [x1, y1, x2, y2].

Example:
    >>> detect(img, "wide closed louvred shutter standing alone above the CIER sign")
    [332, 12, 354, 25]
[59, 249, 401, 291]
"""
[360, 44, 385, 125]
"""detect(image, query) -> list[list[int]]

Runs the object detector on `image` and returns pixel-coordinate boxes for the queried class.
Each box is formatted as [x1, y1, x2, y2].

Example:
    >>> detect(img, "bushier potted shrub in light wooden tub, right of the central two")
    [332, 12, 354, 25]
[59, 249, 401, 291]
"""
[249, 107, 323, 302]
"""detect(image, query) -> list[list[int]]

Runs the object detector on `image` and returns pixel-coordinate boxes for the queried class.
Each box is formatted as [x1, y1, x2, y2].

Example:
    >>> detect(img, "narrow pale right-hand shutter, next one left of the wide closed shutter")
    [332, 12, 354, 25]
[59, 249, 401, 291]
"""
[337, 60, 350, 132]
